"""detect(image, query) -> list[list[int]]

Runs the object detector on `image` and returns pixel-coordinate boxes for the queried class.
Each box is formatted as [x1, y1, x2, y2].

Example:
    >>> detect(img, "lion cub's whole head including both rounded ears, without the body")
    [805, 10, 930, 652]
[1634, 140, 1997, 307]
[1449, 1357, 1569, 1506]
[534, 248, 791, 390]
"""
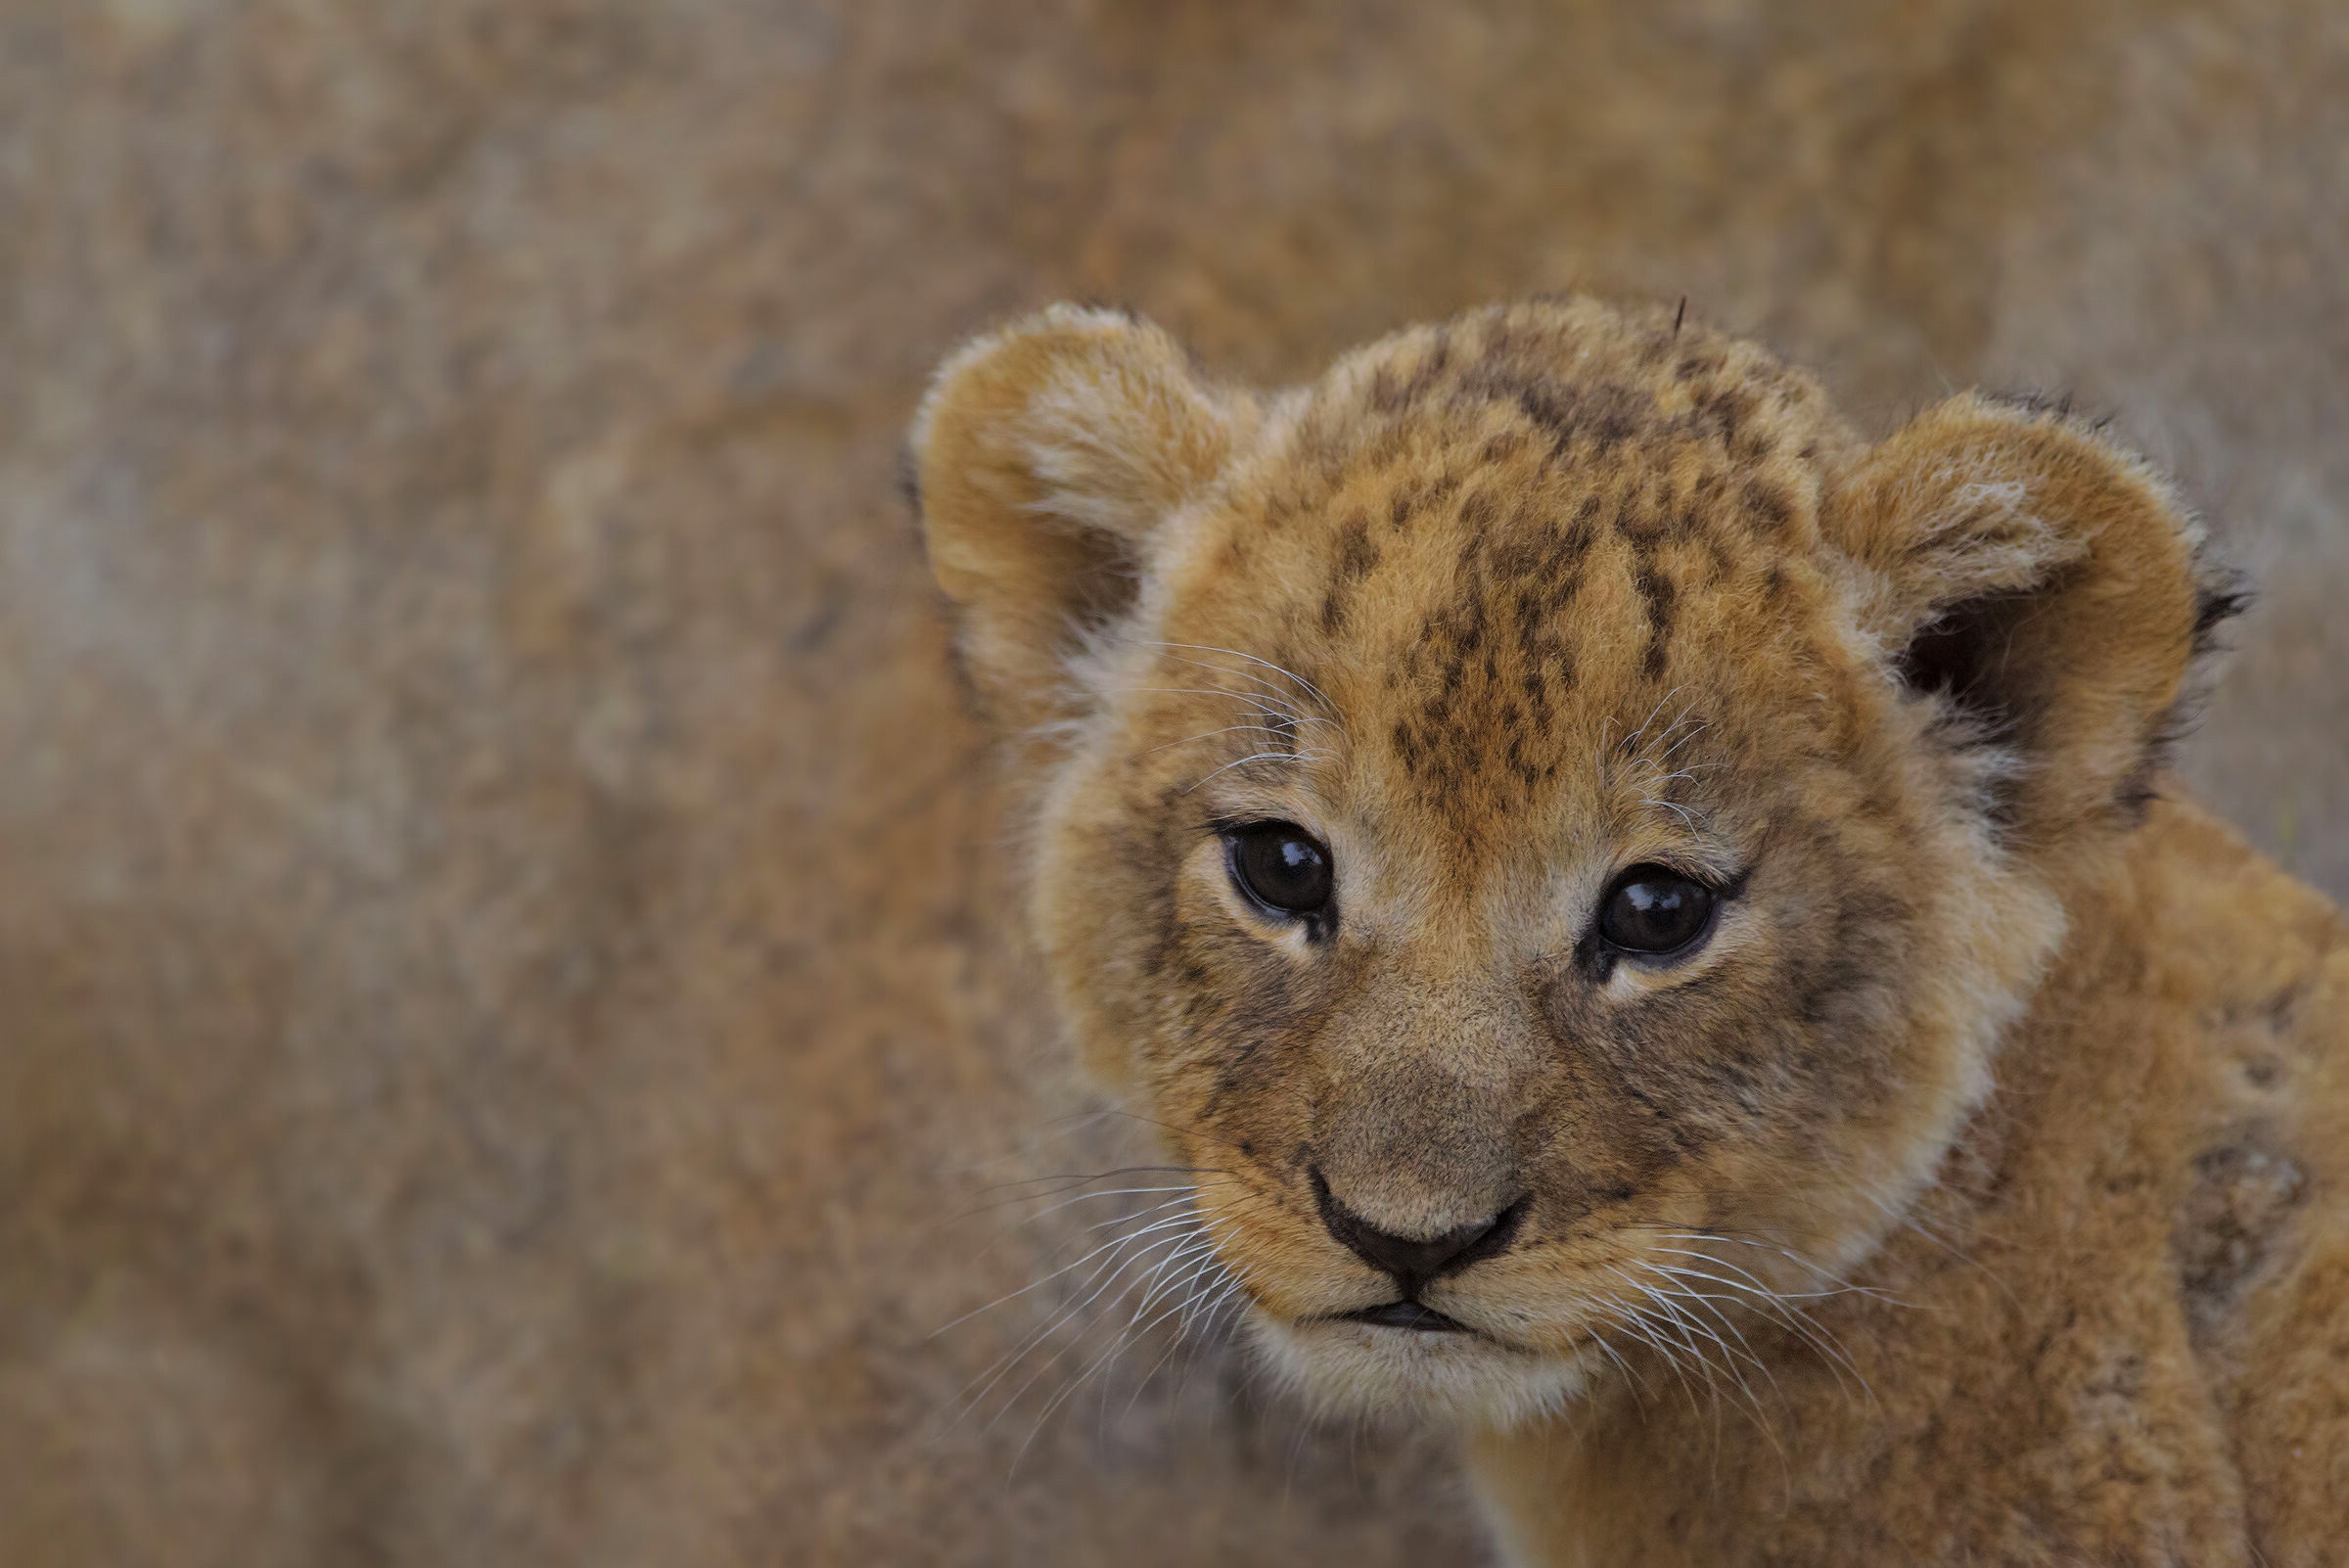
[914, 302, 2203, 1422]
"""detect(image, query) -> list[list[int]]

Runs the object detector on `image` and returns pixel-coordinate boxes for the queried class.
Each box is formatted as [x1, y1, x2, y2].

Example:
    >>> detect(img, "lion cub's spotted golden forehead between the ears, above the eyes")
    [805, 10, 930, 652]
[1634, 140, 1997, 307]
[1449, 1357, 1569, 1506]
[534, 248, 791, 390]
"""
[1146, 302, 1856, 796]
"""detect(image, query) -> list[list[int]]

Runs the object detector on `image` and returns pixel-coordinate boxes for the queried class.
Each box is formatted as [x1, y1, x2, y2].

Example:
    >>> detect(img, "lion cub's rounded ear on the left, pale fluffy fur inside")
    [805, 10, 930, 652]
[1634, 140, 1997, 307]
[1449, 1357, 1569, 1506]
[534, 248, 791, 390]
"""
[911, 305, 1255, 727]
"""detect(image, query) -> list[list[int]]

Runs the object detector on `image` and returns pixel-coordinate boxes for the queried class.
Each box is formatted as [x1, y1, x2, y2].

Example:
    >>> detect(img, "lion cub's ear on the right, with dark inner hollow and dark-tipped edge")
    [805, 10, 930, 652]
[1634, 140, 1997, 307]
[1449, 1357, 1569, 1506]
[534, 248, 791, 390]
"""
[1827, 394, 2241, 854]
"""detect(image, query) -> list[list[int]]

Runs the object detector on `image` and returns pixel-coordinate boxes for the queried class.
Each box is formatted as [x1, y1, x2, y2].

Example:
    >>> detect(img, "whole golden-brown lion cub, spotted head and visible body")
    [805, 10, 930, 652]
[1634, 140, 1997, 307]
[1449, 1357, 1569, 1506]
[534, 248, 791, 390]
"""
[911, 300, 2349, 1566]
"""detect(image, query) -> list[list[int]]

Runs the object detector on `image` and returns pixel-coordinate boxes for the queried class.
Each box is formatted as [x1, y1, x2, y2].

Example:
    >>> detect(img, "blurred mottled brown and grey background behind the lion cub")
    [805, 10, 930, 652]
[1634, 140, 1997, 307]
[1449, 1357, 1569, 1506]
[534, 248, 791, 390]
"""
[0, 0, 2349, 1568]
